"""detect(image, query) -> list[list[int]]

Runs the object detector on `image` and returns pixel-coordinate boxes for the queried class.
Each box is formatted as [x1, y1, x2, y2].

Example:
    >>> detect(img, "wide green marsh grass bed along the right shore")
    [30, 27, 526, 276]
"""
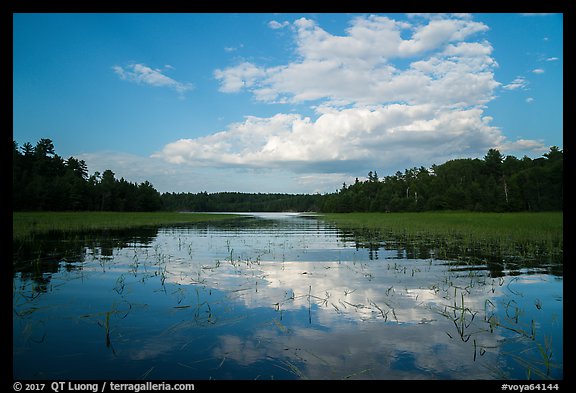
[320, 212, 564, 264]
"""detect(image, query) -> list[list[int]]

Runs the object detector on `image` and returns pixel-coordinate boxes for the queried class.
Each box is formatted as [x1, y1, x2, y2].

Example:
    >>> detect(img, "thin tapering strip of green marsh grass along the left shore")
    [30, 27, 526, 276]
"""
[12, 212, 237, 240]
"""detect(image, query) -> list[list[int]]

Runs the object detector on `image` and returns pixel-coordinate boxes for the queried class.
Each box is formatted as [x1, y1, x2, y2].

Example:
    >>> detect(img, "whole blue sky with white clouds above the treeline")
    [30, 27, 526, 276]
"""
[13, 13, 563, 194]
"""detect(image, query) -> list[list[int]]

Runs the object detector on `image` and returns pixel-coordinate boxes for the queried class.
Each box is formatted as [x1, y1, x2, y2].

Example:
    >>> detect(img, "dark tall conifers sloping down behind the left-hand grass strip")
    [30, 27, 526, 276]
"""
[12, 139, 162, 211]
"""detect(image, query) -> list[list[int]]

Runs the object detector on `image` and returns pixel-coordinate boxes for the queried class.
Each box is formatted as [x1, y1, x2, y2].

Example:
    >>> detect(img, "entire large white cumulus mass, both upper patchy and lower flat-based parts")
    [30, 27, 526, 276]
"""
[154, 15, 544, 181]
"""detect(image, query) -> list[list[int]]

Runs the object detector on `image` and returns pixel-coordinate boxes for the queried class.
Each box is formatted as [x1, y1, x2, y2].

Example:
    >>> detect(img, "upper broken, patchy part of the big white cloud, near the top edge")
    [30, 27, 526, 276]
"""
[214, 15, 498, 106]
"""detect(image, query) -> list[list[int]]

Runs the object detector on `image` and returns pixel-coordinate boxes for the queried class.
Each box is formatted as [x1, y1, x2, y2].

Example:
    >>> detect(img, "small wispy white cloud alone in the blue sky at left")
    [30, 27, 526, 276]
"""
[112, 64, 194, 96]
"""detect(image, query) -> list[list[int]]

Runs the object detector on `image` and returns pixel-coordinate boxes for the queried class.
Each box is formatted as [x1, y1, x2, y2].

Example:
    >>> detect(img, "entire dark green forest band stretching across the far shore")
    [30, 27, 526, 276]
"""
[12, 139, 564, 213]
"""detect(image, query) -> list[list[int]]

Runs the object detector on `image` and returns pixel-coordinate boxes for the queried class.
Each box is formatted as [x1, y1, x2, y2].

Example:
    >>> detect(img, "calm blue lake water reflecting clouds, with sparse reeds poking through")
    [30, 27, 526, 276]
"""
[13, 213, 563, 380]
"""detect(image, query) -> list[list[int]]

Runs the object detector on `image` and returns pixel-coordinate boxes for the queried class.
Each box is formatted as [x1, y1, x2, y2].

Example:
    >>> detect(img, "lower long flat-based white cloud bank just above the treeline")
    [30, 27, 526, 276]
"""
[154, 104, 504, 173]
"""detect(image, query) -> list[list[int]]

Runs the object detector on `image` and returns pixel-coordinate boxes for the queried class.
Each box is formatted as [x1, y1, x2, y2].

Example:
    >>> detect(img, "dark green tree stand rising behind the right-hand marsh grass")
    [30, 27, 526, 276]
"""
[321, 146, 564, 212]
